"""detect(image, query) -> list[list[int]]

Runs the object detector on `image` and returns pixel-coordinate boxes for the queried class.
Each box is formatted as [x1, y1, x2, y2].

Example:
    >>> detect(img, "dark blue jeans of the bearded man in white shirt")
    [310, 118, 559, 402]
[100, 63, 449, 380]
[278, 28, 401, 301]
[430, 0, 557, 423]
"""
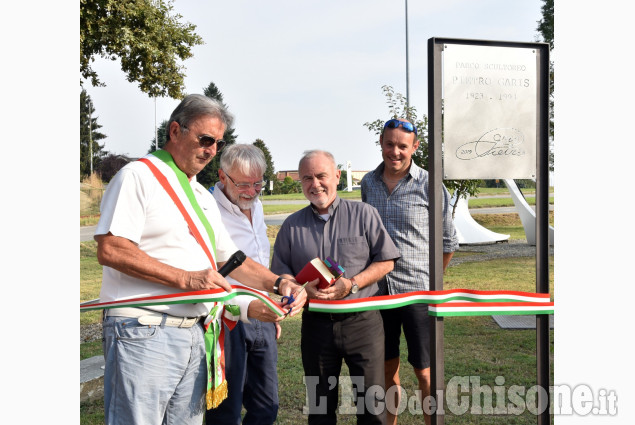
[205, 319, 278, 425]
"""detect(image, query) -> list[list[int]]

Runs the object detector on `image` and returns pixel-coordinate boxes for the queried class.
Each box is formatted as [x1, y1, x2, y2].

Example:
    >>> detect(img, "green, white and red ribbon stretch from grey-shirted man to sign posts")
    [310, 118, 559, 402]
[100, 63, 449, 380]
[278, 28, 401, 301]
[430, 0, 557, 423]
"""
[309, 289, 553, 316]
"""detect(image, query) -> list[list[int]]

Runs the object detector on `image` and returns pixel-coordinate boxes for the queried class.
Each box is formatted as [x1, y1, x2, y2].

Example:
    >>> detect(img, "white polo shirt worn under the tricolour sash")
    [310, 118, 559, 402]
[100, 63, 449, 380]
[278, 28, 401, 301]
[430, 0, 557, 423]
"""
[95, 155, 238, 317]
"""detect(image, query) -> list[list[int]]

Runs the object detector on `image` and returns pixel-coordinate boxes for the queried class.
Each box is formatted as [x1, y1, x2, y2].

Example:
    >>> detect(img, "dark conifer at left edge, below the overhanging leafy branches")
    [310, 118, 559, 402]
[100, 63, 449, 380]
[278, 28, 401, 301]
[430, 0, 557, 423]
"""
[79, 89, 106, 178]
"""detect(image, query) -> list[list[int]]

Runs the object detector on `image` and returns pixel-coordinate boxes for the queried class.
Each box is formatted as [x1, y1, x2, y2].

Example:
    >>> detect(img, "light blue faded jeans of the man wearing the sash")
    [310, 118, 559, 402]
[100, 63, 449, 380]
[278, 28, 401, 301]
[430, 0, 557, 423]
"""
[103, 317, 207, 425]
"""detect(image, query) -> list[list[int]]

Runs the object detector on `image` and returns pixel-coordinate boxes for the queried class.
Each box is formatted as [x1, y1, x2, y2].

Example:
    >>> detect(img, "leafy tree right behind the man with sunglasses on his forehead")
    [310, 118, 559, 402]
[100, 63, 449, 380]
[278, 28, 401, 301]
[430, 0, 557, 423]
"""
[364, 85, 481, 217]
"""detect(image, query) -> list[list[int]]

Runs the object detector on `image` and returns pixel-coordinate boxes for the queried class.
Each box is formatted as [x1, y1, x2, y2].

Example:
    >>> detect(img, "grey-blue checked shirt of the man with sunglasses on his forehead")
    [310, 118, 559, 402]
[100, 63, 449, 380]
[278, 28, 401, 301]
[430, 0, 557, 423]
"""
[362, 162, 459, 295]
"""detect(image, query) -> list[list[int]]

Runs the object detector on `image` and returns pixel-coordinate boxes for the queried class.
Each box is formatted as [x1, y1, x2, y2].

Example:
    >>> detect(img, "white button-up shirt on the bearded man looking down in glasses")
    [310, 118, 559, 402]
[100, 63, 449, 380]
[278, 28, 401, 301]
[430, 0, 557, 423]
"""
[213, 182, 270, 323]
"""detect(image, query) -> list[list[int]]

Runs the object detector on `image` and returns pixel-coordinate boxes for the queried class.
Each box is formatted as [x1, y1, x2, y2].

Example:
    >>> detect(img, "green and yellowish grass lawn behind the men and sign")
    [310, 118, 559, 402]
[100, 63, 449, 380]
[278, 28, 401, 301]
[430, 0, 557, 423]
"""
[80, 214, 553, 424]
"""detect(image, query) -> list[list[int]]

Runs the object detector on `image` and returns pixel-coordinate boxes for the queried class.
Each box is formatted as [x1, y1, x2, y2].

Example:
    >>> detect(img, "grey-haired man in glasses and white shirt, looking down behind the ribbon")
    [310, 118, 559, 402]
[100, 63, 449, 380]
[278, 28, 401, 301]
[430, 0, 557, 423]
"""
[205, 144, 281, 424]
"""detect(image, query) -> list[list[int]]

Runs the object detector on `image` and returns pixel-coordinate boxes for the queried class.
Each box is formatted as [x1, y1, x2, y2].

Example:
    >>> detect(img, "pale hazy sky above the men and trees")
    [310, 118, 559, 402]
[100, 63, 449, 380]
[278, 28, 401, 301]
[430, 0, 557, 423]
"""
[84, 0, 542, 171]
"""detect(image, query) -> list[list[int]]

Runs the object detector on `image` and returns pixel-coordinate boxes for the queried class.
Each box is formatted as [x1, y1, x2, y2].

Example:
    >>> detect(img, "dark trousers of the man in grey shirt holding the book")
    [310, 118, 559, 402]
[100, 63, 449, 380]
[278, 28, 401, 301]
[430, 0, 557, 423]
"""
[301, 310, 386, 425]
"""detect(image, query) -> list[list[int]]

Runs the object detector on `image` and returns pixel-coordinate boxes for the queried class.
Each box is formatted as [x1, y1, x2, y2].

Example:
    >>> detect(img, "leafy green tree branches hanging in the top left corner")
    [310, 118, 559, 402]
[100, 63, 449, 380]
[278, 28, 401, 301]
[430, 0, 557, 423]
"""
[79, 0, 203, 99]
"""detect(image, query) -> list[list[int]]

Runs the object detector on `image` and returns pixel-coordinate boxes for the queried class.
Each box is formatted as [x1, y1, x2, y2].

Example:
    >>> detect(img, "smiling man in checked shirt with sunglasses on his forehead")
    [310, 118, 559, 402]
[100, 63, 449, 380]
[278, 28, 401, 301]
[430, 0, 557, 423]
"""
[361, 119, 459, 425]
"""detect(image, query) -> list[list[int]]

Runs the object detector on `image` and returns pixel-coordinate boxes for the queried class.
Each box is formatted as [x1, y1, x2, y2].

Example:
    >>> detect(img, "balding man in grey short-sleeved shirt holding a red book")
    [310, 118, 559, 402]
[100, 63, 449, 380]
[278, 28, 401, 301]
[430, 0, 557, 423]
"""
[271, 150, 399, 425]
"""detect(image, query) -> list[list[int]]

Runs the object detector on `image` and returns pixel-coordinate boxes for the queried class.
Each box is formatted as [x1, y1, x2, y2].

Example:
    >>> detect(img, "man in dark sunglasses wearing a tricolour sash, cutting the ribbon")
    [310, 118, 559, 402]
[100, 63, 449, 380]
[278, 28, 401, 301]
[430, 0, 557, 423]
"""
[95, 95, 306, 425]
